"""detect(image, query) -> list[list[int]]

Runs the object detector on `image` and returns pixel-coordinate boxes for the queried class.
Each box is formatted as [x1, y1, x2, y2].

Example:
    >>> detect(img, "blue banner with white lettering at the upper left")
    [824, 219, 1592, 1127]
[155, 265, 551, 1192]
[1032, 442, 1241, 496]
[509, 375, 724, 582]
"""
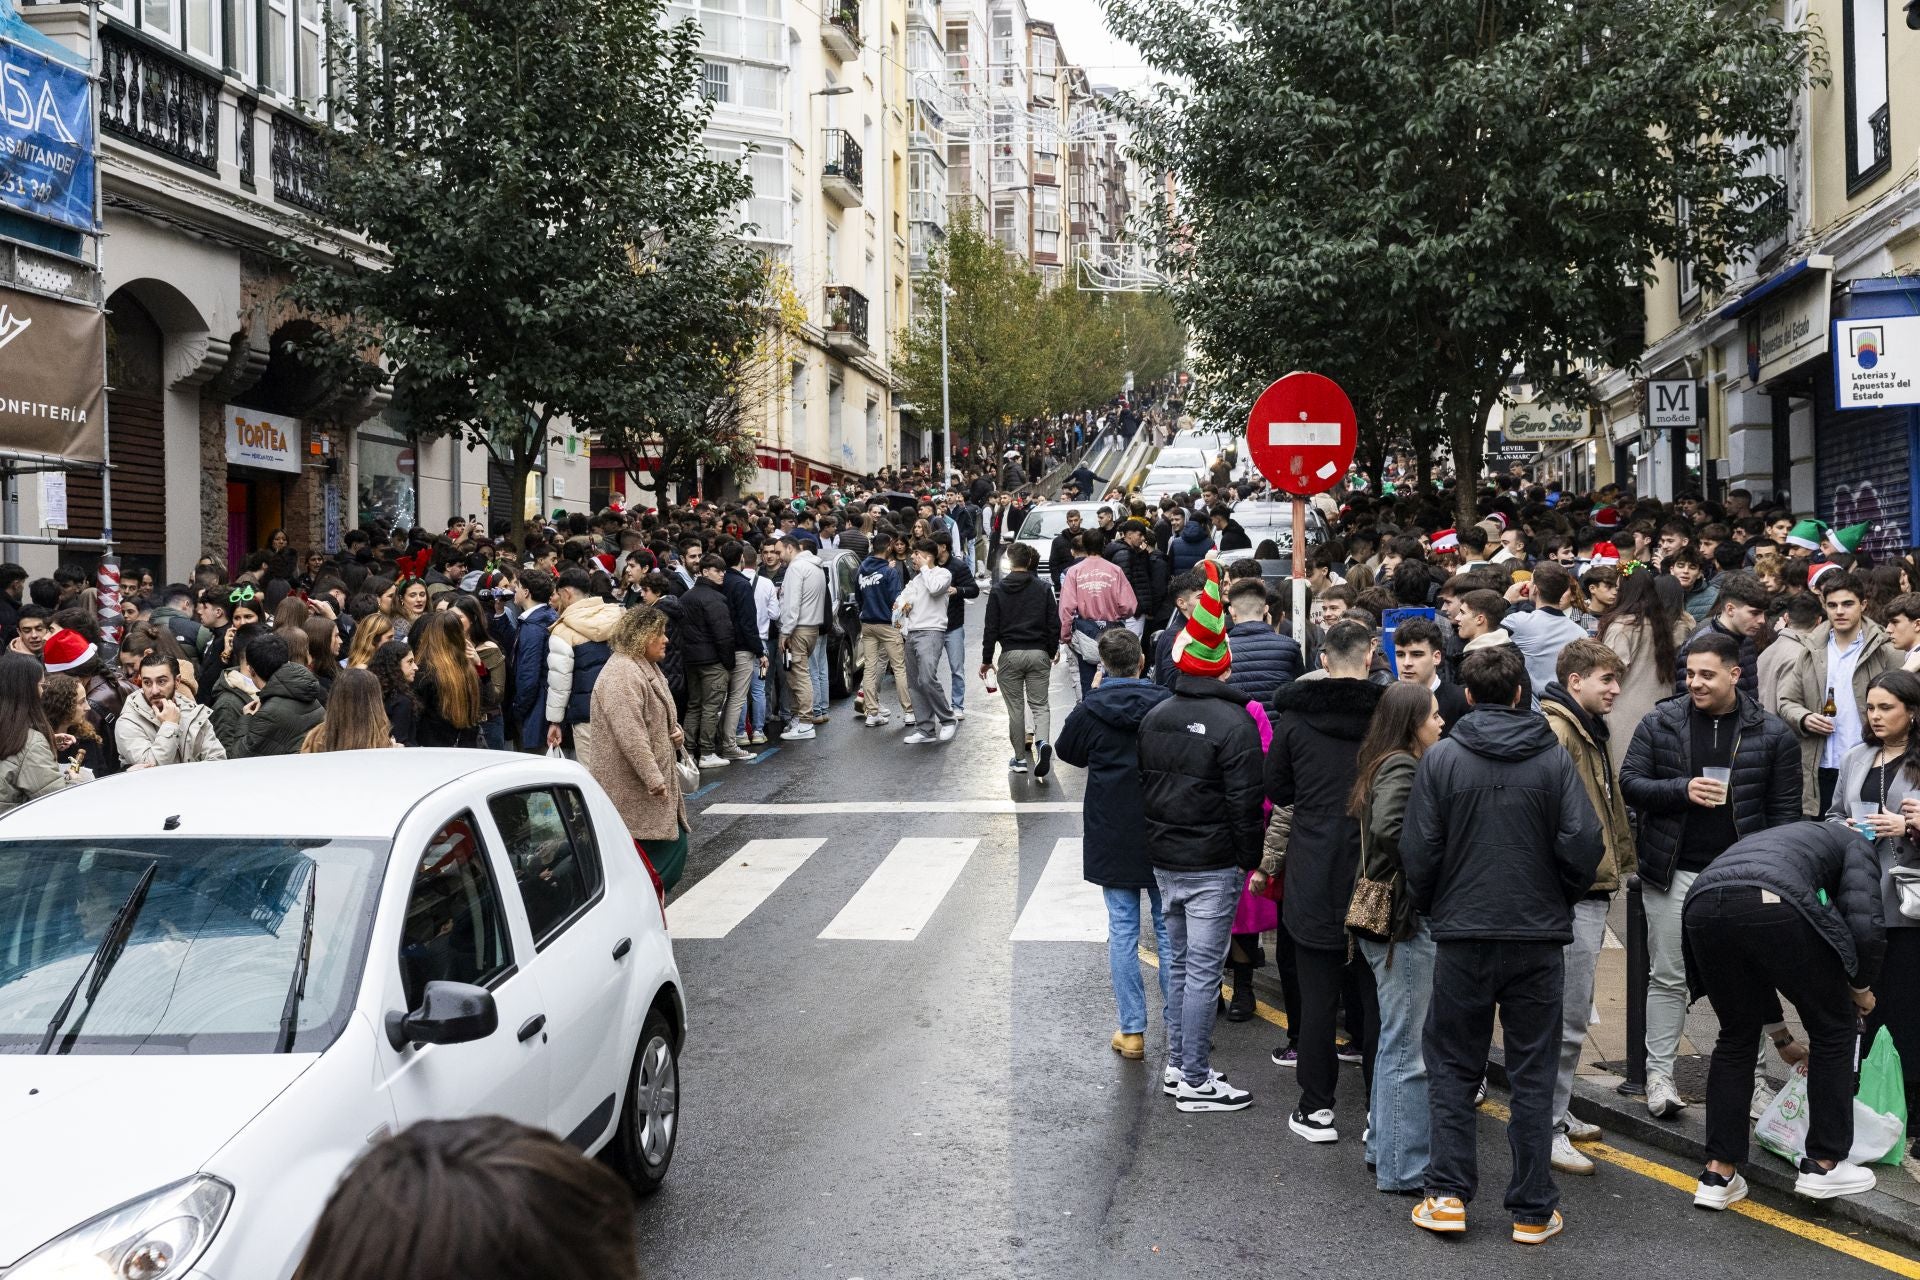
[0, 32, 94, 232]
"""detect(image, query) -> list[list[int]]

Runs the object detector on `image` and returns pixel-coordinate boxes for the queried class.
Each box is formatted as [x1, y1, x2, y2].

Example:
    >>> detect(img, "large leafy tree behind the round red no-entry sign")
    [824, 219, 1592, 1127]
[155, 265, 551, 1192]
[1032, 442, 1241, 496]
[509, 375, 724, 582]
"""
[1106, 0, 1818, 522]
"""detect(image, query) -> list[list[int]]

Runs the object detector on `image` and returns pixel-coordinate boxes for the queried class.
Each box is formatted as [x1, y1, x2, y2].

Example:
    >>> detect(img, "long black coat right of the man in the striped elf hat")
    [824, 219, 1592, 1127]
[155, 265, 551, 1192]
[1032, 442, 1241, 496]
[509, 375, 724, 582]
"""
[1267, 679, 1384, 952]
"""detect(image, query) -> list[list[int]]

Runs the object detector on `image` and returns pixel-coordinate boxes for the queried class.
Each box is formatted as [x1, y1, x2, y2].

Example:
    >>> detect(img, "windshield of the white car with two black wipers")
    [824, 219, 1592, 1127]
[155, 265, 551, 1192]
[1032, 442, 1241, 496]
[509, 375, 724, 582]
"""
[0, 837, 388, 1054]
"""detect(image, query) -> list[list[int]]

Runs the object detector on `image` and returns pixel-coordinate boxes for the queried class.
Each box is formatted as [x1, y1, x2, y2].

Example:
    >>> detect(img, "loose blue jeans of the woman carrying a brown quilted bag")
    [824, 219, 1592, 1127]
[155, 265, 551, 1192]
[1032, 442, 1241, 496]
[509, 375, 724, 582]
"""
[1357, 919, 1434, 1192]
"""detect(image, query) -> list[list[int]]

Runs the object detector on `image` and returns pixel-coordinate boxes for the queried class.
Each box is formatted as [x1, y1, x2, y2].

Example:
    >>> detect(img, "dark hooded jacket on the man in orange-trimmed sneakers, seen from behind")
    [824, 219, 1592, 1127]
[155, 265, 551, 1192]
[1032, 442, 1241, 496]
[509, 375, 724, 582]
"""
[1400, 706, 1601, 946]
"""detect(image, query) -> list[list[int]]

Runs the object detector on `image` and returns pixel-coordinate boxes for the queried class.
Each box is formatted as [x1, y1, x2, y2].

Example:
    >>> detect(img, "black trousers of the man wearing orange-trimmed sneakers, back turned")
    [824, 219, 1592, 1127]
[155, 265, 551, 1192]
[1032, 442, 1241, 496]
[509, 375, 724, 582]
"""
[1423, 942, 1559, 1222]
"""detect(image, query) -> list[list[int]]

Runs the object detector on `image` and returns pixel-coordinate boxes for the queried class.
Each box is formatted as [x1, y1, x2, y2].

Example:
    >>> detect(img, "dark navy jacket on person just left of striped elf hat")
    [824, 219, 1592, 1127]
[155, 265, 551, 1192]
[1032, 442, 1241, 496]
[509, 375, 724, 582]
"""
[1054, 679, 1173, 889]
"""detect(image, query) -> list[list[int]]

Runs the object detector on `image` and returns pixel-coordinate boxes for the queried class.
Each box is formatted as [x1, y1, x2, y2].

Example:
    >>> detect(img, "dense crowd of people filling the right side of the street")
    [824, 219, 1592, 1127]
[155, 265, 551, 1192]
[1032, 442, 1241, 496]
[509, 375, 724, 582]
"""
[1044, 480, 1920, 1244]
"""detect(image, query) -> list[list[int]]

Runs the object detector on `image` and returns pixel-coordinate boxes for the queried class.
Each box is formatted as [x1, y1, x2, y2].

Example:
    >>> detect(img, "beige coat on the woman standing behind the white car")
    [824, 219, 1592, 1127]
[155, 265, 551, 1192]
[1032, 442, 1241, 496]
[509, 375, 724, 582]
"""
[582, 652, 691, 841]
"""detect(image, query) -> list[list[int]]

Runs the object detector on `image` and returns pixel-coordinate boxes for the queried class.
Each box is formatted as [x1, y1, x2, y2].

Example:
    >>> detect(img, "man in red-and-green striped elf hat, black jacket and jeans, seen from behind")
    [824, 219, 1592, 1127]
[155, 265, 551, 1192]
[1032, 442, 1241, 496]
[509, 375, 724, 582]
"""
[1140, 562, 1263, 1111]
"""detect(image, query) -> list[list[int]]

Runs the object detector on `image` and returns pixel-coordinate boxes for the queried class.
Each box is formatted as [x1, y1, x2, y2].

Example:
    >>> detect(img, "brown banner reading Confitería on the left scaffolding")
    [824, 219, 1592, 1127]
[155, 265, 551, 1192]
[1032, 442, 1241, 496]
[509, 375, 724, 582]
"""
[0, 284, 108, 462]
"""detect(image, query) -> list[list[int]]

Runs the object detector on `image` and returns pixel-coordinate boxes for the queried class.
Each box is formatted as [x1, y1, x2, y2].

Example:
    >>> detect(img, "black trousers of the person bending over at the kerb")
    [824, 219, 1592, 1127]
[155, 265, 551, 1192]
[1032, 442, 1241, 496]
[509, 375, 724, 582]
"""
[1682, 885, 1855, 1165]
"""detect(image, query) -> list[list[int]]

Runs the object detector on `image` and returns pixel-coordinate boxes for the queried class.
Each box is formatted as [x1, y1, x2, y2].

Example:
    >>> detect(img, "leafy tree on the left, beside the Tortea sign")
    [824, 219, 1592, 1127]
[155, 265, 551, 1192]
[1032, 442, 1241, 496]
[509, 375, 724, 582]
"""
[288, 0, 758, 541]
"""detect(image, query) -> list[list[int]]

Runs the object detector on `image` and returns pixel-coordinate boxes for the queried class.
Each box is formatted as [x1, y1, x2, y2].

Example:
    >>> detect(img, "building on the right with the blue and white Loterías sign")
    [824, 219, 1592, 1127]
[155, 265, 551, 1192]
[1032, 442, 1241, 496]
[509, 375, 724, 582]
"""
[1597, 0, 1920, 553]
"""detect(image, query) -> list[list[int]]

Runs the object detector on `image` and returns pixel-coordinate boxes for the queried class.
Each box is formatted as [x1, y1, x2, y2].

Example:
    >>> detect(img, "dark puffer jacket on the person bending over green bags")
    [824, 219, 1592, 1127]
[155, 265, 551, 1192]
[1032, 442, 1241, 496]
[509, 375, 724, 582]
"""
[1688, 821, 1881, 986]
